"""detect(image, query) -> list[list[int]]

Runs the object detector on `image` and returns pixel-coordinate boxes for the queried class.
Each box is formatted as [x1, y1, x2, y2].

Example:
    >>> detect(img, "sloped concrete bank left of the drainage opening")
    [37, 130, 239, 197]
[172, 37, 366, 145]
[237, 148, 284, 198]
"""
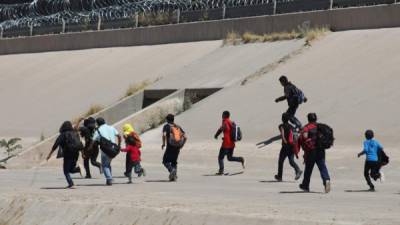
[0, 41, 221, 139]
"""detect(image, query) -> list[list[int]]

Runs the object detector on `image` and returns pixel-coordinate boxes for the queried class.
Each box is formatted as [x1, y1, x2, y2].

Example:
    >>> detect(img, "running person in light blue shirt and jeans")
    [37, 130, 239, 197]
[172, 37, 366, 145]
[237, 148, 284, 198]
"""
[91, 117, 121, 186]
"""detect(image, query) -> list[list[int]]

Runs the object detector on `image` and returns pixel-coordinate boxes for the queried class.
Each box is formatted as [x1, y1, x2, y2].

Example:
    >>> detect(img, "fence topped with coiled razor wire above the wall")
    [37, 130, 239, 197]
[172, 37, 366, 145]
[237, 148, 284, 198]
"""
[0, 0, 397, 38]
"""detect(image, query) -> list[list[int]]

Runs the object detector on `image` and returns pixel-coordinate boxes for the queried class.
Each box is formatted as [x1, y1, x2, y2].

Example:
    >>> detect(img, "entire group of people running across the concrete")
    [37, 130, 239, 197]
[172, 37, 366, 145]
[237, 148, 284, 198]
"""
[47, 76, 388, 193]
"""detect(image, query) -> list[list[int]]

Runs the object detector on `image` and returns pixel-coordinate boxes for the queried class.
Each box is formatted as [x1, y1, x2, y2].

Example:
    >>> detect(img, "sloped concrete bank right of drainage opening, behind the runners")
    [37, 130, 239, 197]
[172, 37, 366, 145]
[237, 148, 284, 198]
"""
[142, 28, 400, 146]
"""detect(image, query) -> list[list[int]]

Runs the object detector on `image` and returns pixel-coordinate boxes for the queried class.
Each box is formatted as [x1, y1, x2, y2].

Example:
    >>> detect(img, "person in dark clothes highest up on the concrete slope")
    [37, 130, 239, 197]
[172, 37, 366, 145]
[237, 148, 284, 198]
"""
[275, 76, 307, 129]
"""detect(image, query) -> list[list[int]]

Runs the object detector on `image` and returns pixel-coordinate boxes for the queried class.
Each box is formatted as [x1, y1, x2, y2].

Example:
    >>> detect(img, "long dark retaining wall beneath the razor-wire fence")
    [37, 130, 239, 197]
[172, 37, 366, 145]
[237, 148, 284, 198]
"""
[0, 4, 400, 54]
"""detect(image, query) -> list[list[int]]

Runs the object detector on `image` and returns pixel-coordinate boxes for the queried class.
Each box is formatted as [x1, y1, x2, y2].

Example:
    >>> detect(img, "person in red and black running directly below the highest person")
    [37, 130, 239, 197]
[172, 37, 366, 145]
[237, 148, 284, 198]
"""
[275, 113, 303, 182]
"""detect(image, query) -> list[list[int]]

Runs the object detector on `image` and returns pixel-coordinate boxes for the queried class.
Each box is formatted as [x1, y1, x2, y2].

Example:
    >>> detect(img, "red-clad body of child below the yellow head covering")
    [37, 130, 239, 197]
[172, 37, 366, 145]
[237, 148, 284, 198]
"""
[121, 135, 146, 183]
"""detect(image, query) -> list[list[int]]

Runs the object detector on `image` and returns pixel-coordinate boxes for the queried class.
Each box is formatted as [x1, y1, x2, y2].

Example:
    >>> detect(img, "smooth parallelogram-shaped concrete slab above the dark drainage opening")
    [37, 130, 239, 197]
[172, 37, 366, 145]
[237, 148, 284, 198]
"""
[151, 40, 304, 89]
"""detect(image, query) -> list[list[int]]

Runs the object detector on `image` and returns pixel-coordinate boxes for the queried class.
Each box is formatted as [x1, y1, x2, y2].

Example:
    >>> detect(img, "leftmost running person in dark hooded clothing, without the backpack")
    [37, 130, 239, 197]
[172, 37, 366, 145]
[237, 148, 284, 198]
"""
[46, 121, 82, 188]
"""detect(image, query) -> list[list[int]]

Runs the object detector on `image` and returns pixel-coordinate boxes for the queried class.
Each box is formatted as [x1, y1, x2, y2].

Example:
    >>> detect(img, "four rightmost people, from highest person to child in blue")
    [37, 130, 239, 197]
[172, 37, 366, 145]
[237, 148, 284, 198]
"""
[275, 76, 389, 193]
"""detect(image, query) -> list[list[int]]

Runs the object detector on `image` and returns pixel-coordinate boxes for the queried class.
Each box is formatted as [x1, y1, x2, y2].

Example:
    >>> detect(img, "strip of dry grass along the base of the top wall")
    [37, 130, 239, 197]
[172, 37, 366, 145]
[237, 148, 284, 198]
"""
[224, 27, 329, 45]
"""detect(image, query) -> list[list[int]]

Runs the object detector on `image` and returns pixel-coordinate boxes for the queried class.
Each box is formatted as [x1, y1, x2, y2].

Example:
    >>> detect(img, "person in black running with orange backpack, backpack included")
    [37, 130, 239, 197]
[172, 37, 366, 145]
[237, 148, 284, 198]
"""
[161, 114, 187, 181]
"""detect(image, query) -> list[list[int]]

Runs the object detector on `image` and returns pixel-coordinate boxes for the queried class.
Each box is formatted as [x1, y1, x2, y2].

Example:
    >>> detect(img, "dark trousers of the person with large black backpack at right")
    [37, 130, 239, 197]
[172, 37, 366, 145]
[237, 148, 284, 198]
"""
[302, 149, 330, 189]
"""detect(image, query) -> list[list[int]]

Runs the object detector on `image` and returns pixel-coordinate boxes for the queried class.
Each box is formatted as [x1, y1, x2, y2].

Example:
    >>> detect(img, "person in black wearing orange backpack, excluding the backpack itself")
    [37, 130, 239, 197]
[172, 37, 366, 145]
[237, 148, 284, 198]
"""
[161, 114, 186, 181]
